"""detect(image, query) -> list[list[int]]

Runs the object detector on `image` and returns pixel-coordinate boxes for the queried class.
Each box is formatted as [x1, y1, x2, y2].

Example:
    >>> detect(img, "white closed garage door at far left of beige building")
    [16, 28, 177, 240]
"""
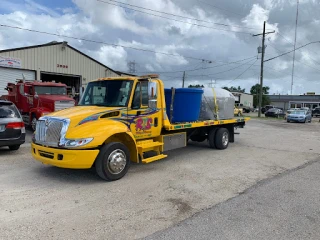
[0, 67, 36, 96]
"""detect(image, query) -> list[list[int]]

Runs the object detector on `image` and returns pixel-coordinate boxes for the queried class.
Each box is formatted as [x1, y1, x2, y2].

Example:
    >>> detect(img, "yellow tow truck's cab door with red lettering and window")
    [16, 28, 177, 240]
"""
[129, 80, 162, 139]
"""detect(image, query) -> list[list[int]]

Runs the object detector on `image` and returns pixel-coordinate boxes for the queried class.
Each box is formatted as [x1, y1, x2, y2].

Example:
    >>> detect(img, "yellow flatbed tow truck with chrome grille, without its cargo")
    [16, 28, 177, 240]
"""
[31, 75, 249, 181]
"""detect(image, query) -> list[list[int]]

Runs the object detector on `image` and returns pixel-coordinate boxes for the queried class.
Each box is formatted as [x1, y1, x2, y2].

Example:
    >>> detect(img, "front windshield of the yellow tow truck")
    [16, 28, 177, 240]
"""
[78, 80, 133, 107]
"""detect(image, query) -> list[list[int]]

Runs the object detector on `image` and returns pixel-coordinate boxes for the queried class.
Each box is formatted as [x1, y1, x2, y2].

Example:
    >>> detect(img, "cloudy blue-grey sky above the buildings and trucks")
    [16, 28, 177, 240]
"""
[0, 0, 320, 94]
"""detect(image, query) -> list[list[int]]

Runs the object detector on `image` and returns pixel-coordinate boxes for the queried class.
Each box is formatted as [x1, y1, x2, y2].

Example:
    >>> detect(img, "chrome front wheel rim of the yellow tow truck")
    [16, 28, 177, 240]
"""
[107, 149, 127, 174]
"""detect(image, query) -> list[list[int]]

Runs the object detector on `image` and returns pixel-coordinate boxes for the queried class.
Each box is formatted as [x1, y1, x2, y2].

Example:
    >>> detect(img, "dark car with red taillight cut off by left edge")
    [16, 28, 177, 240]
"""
[0, 100, 26, 150]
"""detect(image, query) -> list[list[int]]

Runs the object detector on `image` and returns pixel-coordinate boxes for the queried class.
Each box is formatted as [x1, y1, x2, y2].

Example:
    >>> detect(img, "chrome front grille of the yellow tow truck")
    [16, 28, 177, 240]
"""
[35, 119, 63, 146]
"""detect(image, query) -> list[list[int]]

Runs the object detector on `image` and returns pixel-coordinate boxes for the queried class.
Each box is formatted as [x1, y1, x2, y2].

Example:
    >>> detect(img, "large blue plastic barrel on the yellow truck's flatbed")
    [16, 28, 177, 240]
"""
[164, 88, 203, 123]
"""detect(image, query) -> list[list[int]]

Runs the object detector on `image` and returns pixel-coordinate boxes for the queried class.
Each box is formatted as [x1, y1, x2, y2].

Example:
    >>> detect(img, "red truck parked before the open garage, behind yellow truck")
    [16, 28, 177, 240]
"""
[1, 80, 75, 130]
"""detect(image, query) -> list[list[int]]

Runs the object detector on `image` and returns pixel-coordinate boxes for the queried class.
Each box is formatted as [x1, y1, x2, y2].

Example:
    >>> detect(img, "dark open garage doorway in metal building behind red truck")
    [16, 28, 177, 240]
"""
[40, 72, 81, 98]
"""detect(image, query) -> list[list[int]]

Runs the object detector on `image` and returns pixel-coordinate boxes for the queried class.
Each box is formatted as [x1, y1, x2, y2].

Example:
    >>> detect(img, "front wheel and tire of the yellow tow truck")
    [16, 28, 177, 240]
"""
[95, 142, 130, 181]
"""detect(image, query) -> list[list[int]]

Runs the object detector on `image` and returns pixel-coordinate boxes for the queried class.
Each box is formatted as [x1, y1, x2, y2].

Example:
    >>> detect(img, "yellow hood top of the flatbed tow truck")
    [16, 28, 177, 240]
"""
[47, 106, 124, 127]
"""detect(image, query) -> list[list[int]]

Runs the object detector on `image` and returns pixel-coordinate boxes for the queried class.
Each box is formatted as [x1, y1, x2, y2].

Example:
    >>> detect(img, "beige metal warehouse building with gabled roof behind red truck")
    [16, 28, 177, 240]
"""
[0, 42, 123, 96]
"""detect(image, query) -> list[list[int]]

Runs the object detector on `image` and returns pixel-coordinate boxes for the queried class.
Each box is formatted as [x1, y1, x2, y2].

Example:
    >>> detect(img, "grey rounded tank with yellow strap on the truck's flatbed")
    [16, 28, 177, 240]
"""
[199, 88, 235, 120]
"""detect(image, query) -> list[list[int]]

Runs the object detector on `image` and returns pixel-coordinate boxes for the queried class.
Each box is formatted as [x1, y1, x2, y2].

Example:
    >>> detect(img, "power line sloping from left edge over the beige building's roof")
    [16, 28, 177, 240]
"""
[0, 24, 215, 61]
